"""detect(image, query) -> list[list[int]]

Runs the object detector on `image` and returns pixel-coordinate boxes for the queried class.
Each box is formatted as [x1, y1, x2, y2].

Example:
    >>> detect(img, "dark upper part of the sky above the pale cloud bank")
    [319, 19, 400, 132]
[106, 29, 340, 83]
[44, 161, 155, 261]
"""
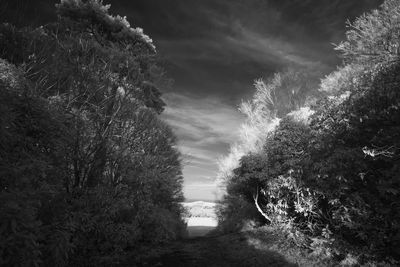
[112, 0, 379, 103]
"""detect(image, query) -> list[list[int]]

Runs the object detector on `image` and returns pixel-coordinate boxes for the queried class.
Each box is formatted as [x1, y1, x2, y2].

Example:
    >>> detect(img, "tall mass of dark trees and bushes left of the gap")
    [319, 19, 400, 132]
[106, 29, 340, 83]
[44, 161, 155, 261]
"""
[0, 0, 185, 266]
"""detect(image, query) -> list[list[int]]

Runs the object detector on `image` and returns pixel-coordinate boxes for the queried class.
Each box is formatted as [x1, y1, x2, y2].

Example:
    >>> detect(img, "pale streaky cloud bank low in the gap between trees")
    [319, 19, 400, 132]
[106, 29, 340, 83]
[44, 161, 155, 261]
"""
[162, 93, 244, 200]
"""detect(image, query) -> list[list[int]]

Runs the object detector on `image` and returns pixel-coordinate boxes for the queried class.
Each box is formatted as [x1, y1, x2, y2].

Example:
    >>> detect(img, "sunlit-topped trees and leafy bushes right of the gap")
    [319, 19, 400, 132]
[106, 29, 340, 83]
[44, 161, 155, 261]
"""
[219, 0, 400, 263]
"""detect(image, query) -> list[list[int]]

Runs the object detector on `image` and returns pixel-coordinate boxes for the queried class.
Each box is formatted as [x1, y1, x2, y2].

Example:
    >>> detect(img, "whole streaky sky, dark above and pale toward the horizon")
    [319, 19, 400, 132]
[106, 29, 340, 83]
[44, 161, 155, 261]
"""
[0, 0, 382, 200]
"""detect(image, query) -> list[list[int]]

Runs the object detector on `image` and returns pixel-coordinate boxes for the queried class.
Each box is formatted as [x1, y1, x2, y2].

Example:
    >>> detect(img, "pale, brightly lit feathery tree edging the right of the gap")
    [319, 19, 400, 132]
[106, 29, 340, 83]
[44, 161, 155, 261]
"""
[219, 68, 320, 184]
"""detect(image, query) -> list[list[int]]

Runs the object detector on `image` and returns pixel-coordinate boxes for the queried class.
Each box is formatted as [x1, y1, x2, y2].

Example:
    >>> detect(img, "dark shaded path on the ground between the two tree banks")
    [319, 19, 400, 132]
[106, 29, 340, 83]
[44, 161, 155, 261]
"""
[145, 233, 297, 267]
